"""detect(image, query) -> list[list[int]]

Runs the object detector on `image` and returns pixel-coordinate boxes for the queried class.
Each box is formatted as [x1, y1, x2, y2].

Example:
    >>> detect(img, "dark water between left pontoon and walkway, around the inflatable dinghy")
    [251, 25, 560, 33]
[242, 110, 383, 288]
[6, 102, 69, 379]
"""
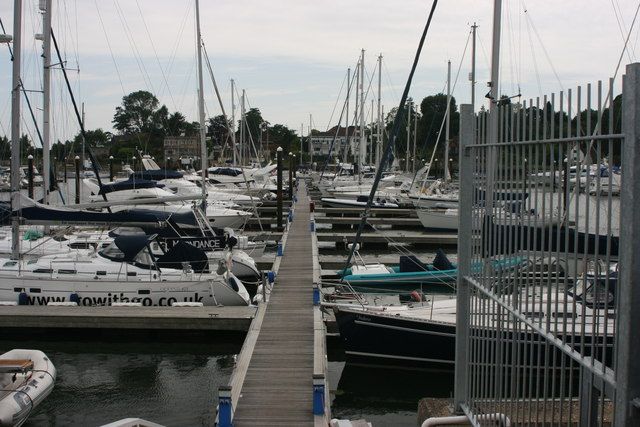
[0, 337, 242, 426]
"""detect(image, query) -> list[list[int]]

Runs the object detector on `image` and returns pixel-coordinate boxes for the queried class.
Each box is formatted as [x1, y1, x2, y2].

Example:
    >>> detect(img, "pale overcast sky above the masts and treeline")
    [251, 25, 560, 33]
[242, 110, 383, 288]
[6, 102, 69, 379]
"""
[0, 0, 640, 145]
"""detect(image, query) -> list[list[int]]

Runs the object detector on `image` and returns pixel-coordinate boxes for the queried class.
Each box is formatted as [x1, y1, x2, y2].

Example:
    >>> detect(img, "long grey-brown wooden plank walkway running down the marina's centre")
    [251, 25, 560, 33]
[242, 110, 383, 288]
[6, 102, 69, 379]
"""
[233, 183, 314, 426]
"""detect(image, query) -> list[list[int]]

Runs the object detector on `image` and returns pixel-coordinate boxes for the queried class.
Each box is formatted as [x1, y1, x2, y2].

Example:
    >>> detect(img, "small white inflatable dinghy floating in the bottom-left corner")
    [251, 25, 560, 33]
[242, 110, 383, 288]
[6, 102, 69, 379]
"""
[0, 349, 56, 427]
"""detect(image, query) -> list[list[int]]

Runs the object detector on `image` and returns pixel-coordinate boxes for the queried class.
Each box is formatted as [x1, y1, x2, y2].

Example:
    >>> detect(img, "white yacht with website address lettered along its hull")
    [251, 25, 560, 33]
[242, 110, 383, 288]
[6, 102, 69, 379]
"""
[0, 235, 249, 306]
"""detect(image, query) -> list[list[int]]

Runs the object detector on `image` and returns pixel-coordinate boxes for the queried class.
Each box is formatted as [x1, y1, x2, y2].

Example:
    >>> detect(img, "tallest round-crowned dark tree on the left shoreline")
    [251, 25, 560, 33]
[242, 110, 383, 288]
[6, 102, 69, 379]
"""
[112, 90, 168, 134]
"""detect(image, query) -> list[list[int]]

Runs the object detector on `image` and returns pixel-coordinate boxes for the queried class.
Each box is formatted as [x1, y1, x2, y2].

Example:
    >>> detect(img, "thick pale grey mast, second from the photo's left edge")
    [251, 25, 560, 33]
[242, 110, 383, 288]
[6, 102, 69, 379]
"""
[41, 0, 52, 204]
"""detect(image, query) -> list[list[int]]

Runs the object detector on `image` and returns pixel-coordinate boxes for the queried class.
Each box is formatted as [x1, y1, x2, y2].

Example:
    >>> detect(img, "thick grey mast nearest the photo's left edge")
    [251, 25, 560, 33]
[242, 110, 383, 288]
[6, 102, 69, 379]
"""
[11, 0, 22, 259]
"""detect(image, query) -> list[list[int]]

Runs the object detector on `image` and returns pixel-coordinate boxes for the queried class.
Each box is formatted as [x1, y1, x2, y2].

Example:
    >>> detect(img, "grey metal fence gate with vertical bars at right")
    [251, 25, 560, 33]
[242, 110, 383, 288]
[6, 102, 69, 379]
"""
[455, 64, 640, 426]
